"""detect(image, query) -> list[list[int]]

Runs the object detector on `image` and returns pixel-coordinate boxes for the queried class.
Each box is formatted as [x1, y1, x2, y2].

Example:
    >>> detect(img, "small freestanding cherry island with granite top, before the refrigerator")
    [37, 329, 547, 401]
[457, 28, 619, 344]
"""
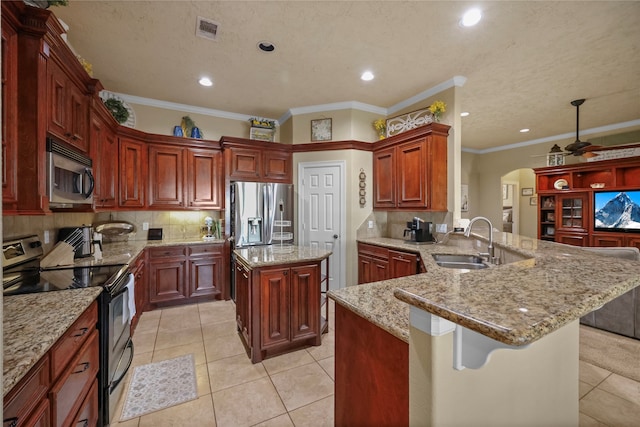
[234, 245, 331, 363]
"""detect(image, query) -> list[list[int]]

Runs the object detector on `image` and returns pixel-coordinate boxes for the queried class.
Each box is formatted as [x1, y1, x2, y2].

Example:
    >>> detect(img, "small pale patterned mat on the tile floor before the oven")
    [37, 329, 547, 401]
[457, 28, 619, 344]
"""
[120, 354, 198, 421]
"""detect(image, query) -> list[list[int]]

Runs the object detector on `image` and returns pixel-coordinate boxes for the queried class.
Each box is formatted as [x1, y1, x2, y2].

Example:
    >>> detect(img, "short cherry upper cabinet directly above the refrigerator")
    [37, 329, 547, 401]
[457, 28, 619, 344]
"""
[220, 136, 293, 184]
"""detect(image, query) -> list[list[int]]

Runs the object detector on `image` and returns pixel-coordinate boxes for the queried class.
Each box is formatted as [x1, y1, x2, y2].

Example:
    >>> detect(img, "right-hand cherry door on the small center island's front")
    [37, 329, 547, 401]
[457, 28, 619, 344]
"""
[291, 265, 320, 340]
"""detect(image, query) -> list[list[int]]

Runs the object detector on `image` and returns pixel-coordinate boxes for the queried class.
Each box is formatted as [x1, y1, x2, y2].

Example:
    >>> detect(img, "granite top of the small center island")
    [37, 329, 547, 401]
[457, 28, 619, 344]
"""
[233, 245, 331, 269]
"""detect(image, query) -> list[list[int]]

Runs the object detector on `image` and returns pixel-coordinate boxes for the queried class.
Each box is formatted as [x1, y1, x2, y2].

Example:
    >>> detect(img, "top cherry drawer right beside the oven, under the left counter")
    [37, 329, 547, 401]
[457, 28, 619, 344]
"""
[51, 302, 98, 378]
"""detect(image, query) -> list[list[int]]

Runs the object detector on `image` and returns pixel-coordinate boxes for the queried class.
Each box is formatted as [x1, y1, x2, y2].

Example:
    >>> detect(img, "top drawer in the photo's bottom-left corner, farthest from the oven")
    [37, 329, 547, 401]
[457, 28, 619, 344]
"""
[3, 355, 50, 426]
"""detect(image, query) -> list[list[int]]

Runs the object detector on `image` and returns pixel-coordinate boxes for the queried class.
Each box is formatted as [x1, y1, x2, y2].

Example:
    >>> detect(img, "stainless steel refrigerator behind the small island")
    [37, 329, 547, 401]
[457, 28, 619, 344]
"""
[231, 182, 294, 247]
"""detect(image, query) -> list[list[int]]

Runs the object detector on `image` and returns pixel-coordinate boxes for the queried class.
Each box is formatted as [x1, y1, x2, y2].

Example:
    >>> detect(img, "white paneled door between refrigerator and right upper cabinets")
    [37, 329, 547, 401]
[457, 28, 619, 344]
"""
[298, 161, 346, 289]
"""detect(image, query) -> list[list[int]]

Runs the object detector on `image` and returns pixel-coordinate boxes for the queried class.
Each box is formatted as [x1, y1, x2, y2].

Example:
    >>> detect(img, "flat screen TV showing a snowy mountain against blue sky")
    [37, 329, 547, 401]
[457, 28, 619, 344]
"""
[593, 190, 640, 233]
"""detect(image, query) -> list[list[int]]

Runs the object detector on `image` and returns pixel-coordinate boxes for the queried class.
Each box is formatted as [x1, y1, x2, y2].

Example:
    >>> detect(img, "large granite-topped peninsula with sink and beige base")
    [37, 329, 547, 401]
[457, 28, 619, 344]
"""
[329, 233, 640, 425]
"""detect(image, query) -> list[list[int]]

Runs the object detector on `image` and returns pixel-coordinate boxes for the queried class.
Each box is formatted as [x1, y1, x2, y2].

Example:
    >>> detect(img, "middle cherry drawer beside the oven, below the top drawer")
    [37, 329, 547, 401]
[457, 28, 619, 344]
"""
[50, 329, 99, 427]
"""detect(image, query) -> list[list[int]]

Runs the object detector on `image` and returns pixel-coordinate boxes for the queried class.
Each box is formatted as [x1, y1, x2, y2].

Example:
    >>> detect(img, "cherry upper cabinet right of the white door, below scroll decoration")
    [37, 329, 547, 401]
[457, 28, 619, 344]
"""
[373, 123, 450, 211]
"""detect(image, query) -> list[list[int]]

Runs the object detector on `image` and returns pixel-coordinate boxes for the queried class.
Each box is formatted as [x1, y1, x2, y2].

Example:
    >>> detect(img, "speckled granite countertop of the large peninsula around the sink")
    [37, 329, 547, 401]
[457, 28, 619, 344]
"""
[329, 232, 640, 346]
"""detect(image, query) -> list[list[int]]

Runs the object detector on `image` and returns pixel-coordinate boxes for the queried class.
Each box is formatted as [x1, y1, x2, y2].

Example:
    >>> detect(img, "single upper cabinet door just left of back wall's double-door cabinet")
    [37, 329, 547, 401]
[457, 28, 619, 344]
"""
[119, 138, 147, 208]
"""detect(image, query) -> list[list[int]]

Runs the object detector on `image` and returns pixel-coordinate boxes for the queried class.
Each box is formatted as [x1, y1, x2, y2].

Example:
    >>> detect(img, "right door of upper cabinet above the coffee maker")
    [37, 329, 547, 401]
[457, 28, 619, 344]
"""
[396, 141, 427, 208]
